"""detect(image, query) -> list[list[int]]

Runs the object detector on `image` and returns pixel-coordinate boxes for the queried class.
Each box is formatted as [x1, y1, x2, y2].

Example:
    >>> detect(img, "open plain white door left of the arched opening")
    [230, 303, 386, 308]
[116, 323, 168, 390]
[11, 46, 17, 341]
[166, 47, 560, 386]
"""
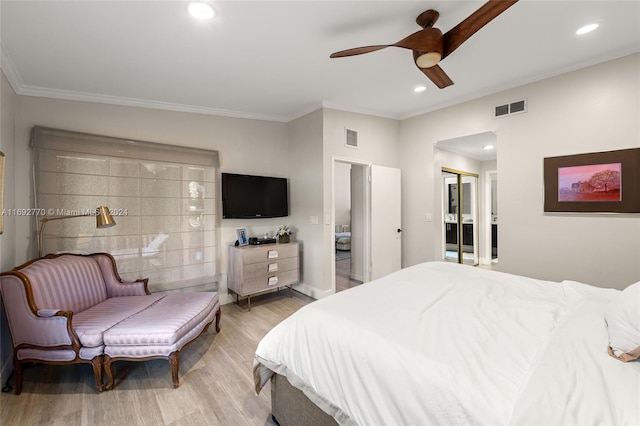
[370, 166, 402, 280]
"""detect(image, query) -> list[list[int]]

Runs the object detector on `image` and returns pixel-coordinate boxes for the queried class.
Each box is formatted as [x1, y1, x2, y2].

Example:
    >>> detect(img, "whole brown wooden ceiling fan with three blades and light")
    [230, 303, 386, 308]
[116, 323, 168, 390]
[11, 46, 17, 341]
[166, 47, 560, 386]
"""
[330, 0, 518, 89]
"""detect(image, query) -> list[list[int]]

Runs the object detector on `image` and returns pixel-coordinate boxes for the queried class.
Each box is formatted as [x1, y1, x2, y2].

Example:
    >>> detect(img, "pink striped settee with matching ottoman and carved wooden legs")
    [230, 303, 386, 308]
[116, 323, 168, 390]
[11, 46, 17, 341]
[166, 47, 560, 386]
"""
[0, 253, 220, 394]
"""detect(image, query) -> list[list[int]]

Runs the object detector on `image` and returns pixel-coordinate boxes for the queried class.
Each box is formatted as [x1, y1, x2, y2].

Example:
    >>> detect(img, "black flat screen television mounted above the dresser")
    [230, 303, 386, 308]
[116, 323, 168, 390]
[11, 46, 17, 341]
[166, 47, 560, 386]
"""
[222, 173, 289, 219]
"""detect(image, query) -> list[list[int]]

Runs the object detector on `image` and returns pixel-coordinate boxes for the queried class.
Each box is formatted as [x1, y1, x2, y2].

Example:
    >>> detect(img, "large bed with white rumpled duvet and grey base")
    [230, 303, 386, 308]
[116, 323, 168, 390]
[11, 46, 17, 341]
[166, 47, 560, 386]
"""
[254, 262, 640, 426]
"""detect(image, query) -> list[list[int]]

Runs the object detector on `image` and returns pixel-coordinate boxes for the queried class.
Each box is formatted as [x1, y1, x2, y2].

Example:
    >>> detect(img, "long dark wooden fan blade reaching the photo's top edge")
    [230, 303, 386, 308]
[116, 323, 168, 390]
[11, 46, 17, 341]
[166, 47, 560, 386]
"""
[442, 0, 518, 59]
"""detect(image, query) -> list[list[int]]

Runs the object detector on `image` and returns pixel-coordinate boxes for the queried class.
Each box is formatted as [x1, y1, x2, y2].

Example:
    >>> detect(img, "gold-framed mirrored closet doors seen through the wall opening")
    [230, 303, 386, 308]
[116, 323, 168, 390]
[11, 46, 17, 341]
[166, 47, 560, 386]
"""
[442, 167, 479, 265]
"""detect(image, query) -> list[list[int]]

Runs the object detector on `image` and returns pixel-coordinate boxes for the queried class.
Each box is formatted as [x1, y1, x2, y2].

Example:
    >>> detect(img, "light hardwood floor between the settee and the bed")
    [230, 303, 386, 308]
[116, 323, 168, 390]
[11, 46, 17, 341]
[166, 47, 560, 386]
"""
[0, 290, 312, 426]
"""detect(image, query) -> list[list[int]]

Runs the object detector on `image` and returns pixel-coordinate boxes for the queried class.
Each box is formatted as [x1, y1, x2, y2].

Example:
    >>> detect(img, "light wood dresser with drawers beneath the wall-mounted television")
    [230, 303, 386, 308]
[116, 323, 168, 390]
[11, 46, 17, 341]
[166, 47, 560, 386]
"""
[227, 242, 300, 309]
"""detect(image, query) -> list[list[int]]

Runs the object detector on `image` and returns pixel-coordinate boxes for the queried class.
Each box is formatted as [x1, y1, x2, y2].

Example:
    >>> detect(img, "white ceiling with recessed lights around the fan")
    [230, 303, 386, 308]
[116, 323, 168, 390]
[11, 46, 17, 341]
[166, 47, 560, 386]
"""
[0, 0, 640, 122]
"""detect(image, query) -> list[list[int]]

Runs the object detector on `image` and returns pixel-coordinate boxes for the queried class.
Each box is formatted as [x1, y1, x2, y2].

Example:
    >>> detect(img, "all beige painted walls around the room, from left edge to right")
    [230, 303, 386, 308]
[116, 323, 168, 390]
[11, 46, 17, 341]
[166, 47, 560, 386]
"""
[0, 54, 640, 386]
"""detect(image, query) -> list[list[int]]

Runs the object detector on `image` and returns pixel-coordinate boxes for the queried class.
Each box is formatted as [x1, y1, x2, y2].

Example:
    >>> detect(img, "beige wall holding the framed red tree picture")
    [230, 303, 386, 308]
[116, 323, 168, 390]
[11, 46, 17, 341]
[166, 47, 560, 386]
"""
[400, 54, 640, 288]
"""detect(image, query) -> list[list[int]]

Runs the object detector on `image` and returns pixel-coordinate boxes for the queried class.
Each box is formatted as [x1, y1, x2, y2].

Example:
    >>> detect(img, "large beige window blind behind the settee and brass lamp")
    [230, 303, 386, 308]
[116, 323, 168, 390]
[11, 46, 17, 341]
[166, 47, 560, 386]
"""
[31, 126, 219, 291]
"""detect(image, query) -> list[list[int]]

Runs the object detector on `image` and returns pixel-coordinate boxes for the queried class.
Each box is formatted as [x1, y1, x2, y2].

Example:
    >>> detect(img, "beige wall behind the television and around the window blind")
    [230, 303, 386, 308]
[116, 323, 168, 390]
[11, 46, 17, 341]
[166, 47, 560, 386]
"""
[8, 96, 289, 302]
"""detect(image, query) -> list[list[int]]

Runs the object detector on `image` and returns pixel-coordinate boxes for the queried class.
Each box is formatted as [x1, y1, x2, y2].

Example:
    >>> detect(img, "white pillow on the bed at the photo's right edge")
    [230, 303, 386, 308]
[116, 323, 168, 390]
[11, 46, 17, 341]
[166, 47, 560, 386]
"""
[605, 281, 640, 362]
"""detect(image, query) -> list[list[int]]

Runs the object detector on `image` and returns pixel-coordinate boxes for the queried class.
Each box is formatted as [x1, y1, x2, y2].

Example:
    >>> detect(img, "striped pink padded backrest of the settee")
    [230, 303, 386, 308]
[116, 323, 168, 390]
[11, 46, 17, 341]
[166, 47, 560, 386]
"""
[22, 255, 107, 312]
